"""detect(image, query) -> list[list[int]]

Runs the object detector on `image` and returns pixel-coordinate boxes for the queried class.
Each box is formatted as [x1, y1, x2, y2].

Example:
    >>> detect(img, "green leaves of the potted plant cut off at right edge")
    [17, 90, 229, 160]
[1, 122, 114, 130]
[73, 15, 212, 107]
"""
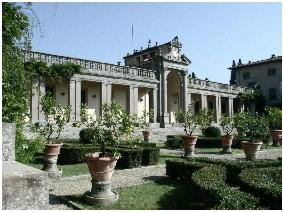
[265, 107, 282, 130]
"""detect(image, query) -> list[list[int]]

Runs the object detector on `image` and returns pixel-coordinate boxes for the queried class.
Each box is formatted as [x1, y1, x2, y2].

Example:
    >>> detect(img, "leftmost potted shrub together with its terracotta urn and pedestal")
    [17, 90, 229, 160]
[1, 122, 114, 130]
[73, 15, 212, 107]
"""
[34, 94, 71, 177]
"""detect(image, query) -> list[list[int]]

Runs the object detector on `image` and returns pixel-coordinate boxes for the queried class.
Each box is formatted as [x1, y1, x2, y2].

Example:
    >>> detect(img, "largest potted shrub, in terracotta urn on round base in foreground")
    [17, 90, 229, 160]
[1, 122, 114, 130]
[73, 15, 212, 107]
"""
[84, 102, 135, 205]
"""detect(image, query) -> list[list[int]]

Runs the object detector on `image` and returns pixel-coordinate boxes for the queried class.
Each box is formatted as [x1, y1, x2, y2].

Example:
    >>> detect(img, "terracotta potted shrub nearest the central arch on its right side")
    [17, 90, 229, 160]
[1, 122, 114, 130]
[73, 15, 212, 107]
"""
[175, 106, 199, 157]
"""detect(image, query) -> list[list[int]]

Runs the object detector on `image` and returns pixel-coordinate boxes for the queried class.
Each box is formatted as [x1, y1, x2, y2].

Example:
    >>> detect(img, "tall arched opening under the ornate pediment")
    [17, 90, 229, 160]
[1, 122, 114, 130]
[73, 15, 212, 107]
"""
[167, 71, 181, 123]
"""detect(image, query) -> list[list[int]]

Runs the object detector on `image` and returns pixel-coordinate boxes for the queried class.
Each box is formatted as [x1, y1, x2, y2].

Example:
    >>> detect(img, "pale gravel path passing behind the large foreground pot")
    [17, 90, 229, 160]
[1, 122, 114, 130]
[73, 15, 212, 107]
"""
[50, 149, 282, 210]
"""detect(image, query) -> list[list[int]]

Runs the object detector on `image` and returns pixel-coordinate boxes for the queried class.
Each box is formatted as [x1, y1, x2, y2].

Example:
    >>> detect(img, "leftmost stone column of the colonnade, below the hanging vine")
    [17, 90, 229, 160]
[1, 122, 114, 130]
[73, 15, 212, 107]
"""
[30, 79, 39, 122]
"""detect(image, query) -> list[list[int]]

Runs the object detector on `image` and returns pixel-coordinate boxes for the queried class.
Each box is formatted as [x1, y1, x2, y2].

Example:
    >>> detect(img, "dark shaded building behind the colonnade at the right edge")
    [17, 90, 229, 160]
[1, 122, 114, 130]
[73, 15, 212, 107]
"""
[228, 55, 282, 106]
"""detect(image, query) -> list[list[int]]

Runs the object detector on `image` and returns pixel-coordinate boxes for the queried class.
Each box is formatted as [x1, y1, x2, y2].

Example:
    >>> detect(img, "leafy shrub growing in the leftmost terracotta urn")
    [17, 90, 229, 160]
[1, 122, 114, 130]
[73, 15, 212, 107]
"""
[33, 94, 71, 143]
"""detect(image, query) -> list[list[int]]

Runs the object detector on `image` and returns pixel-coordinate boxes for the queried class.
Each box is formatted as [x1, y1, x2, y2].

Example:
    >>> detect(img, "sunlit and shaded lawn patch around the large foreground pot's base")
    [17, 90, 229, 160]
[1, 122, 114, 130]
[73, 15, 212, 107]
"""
[65, 179, 214, 210]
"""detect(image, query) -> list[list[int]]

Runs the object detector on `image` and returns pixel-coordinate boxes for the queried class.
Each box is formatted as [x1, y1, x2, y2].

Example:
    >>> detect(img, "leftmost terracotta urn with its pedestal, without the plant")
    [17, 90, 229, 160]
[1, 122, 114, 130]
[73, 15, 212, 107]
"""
[42, 143, 63, 177]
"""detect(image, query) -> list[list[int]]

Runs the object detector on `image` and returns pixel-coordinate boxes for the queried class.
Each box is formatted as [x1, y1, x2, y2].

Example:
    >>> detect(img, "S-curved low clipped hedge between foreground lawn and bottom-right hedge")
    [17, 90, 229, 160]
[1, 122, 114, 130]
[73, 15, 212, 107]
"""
[192, 165, 259, 210]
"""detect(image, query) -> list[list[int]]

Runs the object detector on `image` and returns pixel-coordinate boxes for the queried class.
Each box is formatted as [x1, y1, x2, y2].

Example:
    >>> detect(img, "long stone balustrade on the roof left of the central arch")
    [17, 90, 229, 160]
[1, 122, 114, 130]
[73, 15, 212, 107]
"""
[25, 52, 156, 80]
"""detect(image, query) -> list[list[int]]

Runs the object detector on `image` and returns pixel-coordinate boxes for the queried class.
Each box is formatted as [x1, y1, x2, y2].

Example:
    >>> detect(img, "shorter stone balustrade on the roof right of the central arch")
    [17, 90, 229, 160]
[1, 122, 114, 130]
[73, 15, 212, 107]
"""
[188, 78, 251, 93]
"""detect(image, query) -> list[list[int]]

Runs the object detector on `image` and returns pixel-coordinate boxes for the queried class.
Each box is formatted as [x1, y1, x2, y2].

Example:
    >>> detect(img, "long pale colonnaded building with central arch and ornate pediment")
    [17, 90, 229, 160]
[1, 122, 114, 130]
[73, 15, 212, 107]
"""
[25, 37, 246, 127]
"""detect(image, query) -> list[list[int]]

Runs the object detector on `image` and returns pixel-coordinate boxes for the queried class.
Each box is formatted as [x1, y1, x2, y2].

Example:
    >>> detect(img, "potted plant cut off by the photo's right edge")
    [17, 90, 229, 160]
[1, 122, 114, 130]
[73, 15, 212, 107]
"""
[265, 107, 282, 146]
